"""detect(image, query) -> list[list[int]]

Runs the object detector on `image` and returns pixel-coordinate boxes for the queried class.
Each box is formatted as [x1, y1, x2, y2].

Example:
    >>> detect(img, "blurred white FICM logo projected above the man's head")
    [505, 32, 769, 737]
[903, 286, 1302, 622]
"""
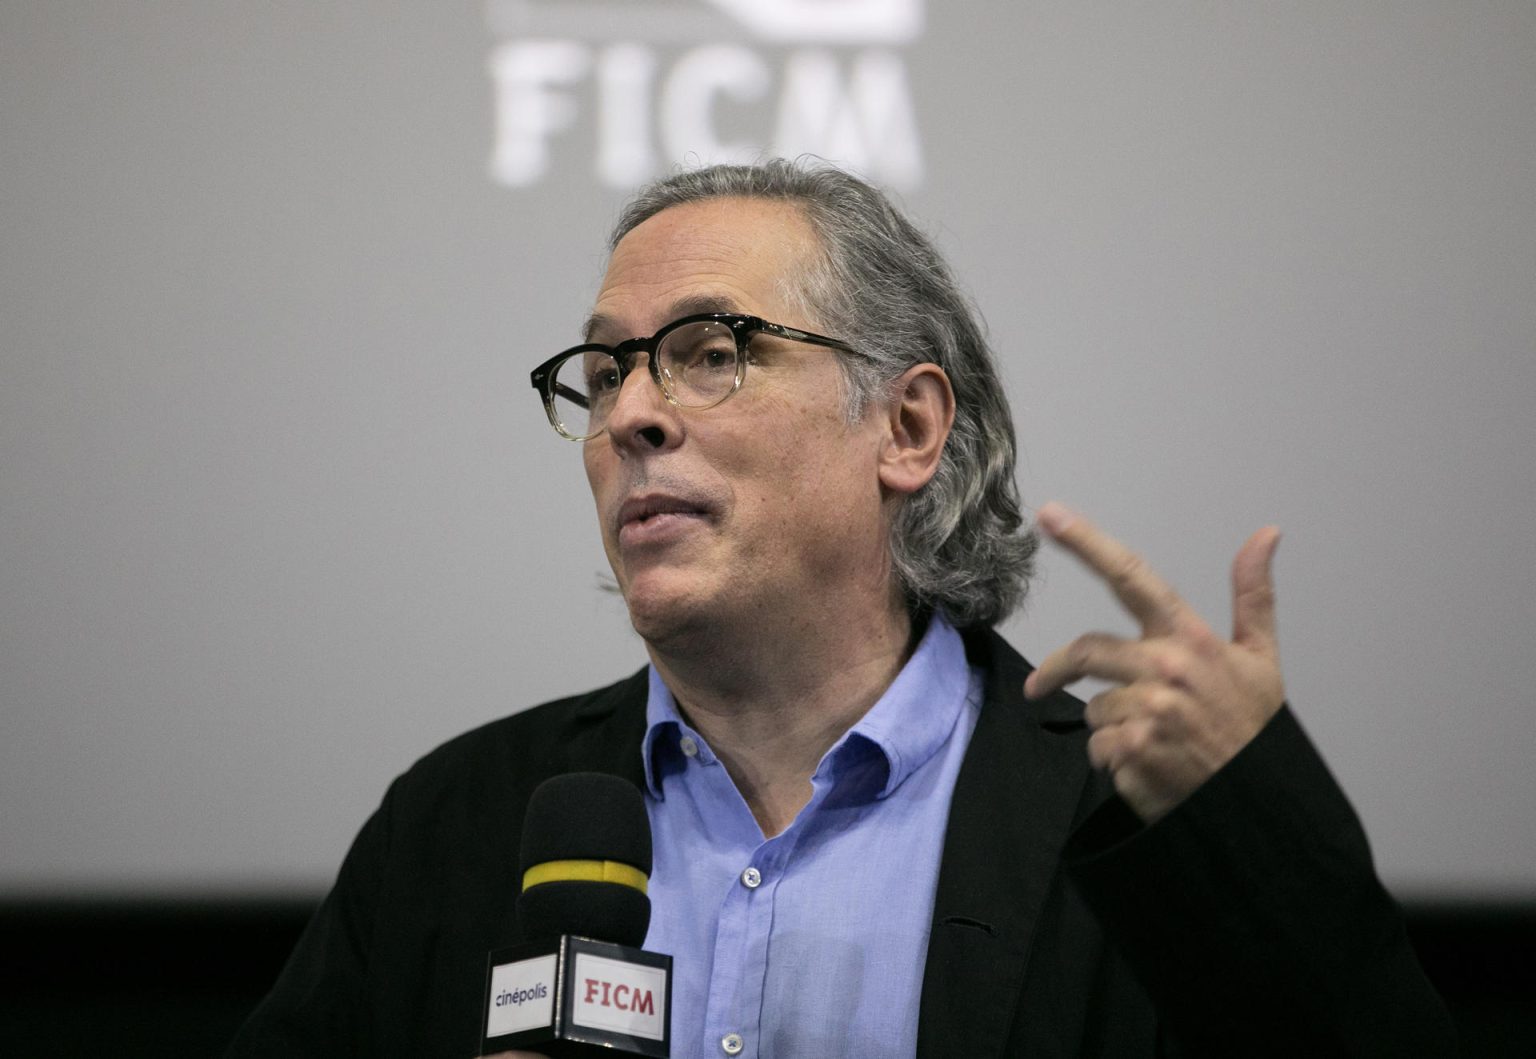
[487, 0, 923, 189]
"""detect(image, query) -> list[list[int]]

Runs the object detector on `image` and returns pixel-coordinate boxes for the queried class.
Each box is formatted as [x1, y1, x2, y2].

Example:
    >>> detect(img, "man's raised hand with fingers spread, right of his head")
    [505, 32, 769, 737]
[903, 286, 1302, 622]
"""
[1025, 503, 1286, 824]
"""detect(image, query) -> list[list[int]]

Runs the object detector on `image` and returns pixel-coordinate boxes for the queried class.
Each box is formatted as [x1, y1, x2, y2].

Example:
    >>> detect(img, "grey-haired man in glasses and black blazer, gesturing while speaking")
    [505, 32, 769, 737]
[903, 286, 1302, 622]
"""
[232, 161, 1452, 1056]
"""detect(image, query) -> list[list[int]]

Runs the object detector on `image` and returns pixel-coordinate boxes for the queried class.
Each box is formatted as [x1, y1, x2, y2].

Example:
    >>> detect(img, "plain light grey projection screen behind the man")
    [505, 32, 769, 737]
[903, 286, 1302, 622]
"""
[0, 0, 1536, 898]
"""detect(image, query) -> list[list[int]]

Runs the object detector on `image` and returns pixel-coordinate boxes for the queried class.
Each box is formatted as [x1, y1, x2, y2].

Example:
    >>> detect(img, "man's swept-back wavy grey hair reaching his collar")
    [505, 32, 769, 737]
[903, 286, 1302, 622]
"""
[608, 158, 1040, 627]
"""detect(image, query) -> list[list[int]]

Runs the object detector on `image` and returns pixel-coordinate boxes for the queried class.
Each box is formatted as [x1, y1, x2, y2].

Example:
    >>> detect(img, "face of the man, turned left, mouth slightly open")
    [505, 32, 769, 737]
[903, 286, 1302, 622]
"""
[584, 198, 891, 652]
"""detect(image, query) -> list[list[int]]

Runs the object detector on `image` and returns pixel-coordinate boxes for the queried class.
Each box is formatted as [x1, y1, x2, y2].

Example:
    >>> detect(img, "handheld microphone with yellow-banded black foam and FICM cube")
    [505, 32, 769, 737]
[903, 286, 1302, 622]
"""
[481, 772, 671, 1059]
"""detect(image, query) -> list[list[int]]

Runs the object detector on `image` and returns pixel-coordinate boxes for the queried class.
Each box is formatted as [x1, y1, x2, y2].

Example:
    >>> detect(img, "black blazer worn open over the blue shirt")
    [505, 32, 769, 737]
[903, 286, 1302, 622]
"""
[229, 632, 1455, 1059]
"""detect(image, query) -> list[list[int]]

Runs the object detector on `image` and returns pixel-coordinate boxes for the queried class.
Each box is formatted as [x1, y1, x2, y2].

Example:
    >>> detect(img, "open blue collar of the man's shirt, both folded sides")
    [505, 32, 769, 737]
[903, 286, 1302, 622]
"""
[641, 613, 971, 798]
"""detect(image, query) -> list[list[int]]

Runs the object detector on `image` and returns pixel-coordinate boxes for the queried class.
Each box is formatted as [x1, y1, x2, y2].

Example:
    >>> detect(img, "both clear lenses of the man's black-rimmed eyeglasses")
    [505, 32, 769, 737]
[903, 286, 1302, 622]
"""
[551, 320, 740, 438]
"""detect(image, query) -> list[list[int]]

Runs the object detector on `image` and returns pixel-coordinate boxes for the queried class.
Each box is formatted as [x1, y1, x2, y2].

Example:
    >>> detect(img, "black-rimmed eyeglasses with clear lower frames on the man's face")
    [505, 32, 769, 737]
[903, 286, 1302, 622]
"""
[533, 312, 857, 441]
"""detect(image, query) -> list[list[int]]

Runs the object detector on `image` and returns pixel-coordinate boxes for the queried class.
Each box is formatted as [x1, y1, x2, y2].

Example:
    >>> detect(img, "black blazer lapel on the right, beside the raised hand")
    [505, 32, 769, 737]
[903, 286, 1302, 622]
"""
[917, 630, 1089, 1056]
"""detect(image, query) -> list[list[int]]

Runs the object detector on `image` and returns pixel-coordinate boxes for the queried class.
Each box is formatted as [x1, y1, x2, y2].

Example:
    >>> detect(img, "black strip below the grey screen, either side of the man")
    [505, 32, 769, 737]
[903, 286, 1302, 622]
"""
[0, 899, 1536, 1059]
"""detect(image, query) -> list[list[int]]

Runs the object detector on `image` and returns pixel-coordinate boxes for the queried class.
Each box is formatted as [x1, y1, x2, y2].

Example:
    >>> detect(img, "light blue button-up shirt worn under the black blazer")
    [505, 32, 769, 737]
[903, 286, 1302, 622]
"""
[644, 615, 982, 1059]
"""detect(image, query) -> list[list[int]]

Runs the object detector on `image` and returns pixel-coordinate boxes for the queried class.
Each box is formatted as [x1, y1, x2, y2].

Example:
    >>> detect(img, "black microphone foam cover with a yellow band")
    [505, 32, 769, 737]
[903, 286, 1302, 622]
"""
[518, 772, 651, 947]
